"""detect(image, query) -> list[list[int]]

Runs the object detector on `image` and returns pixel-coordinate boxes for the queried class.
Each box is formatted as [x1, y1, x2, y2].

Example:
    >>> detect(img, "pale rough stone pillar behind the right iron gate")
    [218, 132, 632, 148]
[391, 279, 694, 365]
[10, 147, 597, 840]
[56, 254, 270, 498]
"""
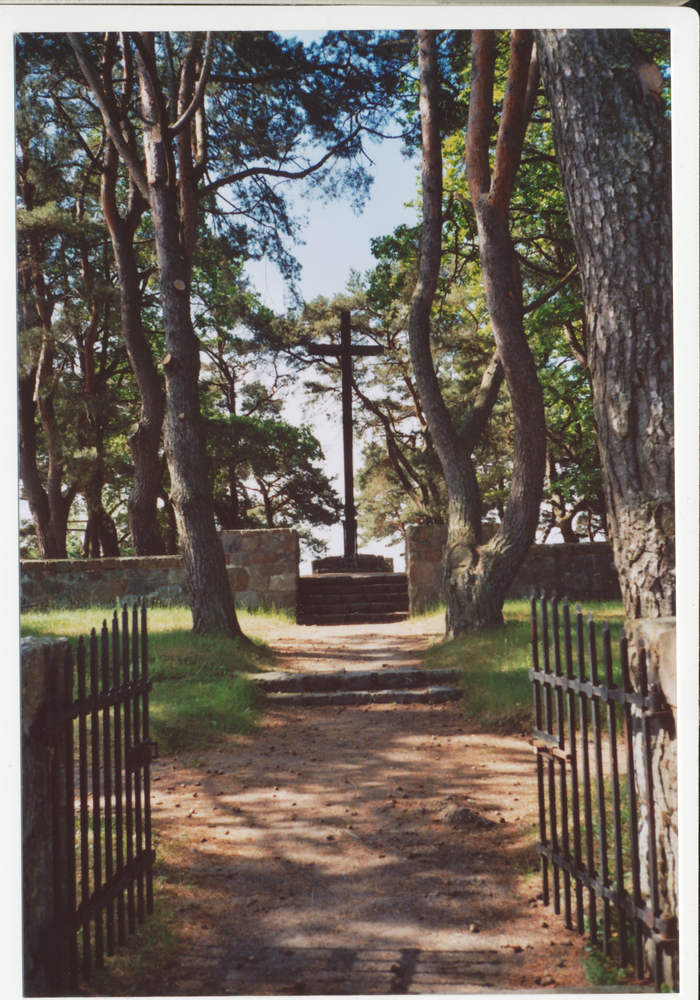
[625, 618, 679, 992]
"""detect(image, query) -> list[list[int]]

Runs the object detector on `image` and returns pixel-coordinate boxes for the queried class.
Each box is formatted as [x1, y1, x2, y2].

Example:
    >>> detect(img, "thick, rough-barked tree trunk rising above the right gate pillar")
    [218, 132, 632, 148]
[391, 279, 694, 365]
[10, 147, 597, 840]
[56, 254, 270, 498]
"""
[537, 30, 675, 619]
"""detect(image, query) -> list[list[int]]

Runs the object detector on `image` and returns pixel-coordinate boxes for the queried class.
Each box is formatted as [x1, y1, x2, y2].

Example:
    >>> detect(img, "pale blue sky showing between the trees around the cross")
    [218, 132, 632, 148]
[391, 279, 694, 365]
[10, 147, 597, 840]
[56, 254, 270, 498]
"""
[247, 139, 420, 573]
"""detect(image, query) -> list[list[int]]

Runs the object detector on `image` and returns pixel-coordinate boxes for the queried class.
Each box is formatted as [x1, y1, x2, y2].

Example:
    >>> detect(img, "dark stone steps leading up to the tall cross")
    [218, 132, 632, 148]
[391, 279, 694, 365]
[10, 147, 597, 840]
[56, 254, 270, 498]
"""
[297, 573, 409, 625]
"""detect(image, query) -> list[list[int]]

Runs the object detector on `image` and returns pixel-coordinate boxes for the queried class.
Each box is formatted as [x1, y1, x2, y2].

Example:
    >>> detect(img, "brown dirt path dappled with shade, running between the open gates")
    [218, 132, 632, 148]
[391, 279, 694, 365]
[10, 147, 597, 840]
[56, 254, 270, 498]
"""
[110, 622, 596, 996]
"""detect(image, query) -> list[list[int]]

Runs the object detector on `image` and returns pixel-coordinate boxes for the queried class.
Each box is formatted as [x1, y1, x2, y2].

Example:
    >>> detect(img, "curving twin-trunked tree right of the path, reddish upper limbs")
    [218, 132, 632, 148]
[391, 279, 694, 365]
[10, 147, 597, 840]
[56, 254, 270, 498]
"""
[409, 31, 546, 636]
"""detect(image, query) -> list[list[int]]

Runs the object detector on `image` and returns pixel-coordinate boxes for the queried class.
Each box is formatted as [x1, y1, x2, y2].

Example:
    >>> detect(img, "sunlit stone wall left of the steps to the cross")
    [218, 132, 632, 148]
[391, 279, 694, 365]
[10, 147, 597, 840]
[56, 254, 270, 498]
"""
[20, 528, 299, 612]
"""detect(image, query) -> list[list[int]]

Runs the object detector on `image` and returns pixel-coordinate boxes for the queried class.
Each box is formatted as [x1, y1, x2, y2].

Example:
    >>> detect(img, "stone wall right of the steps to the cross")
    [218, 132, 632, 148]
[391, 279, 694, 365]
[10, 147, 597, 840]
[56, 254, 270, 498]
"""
[406, 524, 620, 614]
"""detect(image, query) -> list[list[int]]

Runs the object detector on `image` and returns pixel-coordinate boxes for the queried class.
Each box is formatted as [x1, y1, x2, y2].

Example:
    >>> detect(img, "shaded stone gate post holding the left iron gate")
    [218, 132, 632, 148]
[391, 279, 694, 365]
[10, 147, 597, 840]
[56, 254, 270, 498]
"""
[20, 638, 74, 996]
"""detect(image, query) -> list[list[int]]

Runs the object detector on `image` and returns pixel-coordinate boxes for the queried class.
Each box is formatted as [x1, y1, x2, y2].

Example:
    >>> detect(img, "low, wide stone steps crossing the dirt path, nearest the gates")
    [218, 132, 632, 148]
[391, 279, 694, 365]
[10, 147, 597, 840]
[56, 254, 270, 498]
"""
[248, 668, 464, 708]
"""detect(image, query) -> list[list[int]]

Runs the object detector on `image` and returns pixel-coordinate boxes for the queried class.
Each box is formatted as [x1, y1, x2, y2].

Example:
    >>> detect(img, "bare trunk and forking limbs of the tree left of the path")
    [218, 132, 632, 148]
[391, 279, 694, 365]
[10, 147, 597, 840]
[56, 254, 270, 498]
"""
[69, 32, 242, 637]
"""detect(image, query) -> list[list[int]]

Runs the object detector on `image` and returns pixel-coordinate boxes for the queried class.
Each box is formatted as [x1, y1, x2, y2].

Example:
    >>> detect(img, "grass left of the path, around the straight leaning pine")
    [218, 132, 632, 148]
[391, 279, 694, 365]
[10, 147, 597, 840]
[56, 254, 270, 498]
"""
[21, 607, 288, 752]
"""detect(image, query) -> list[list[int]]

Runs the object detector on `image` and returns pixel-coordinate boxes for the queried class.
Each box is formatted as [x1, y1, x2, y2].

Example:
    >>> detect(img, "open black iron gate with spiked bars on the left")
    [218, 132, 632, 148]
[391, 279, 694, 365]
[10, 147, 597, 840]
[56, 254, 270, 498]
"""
[48, 603, 155, 990]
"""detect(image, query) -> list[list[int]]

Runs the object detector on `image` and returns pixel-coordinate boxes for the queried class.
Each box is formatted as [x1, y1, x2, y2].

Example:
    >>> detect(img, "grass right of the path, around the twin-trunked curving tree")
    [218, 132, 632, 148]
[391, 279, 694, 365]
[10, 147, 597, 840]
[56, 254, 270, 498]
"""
[424, 600, 624, 732]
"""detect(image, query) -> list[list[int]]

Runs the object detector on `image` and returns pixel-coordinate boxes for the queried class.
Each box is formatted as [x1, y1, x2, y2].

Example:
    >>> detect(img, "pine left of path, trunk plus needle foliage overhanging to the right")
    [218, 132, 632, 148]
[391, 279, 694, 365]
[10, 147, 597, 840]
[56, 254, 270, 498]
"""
[69, 32, 410, 635]
